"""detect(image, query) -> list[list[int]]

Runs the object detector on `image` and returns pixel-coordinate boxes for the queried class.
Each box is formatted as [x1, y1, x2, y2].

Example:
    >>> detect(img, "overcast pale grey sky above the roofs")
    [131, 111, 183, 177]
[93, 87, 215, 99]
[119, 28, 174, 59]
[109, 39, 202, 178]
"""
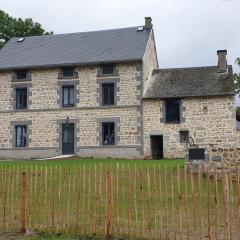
[0, 0, 240, 102]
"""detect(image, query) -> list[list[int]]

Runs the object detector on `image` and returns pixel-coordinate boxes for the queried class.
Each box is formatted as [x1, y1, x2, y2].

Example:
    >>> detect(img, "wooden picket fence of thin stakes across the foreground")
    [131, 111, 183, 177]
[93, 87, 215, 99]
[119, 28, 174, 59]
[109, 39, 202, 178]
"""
[0, 162, 240, 239]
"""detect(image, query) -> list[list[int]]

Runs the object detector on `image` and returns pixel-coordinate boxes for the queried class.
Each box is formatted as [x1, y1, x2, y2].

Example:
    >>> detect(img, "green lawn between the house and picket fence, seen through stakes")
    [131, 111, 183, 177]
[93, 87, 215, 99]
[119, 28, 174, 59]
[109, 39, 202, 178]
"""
[0, 158, 237, 240]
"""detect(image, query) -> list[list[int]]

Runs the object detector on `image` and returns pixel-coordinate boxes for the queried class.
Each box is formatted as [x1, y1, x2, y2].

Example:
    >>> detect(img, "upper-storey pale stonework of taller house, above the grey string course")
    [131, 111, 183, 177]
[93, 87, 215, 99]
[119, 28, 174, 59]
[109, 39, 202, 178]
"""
[0, 62, 141, 111]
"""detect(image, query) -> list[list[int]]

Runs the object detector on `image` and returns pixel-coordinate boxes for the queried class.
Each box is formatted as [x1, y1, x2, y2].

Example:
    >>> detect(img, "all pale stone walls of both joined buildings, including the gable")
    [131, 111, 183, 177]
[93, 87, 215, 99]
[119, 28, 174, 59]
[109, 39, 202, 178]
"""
[0, 26, 237, 161]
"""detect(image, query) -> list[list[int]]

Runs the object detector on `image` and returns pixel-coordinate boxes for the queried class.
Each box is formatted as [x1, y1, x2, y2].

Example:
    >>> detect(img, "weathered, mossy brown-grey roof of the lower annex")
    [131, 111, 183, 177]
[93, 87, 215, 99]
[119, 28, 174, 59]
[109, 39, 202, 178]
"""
[144, 66, 235, 98]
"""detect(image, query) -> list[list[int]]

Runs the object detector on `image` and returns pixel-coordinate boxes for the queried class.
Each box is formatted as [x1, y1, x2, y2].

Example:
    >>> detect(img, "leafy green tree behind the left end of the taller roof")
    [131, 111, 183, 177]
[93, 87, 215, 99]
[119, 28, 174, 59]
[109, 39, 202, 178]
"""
[0, 10, 53, 48]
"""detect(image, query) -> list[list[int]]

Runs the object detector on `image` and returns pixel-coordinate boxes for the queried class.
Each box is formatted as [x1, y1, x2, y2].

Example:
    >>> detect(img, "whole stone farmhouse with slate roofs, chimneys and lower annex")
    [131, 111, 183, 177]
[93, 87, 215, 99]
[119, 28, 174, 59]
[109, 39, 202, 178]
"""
[0, 17, 239, 160]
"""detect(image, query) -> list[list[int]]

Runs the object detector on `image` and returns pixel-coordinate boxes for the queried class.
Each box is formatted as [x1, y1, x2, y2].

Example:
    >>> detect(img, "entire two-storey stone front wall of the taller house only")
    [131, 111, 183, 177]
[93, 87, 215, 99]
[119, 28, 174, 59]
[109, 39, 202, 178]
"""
[0, 62, 142, 158]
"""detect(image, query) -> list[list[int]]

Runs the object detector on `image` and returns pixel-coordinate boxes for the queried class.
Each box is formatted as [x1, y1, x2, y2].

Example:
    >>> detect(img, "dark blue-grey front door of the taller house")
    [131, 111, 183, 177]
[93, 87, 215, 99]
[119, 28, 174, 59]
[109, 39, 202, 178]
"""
[62, 123, 74, 154]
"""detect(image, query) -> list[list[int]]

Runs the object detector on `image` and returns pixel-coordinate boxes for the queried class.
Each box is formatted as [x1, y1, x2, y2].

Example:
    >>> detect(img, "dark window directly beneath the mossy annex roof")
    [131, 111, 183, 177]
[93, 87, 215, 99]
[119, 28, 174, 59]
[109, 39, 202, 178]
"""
[165, 99, 180, 123]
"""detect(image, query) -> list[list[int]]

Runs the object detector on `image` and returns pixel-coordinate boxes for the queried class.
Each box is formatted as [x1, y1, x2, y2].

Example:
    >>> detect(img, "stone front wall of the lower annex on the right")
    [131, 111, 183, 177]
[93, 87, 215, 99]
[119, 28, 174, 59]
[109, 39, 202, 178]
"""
[143, 97, 239, 158]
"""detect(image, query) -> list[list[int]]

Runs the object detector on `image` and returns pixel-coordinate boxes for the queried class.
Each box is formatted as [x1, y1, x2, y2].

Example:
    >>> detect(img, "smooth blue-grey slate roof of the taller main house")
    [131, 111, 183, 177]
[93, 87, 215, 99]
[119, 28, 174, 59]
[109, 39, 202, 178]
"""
[0, 27, 151, 70]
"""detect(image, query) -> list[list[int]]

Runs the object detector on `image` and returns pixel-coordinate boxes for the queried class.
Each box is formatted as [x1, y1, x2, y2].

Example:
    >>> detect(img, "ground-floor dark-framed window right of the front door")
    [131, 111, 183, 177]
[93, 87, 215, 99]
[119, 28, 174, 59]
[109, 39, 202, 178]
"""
[102, 122, 116, 146]
